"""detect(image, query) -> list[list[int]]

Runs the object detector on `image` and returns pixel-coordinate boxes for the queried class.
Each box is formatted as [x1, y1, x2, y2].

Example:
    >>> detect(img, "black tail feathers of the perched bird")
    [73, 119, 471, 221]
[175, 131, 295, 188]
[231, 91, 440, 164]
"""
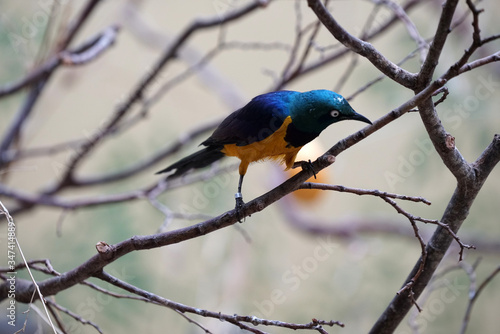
[156, 146, 225, 179]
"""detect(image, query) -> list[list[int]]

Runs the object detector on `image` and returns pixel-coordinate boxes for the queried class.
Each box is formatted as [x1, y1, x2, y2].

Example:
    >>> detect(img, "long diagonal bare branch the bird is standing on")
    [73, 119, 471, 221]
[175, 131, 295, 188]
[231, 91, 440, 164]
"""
[0, 67, 454, 301]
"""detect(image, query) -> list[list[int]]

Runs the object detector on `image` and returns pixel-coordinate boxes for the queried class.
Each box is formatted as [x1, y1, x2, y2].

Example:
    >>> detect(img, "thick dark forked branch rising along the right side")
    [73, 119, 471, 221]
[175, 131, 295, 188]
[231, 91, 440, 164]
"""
[370, 10, 500, 318]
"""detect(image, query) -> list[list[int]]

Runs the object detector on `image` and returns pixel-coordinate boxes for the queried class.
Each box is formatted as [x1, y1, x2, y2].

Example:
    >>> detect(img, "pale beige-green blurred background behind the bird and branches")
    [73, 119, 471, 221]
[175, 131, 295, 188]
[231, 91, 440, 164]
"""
[0, 0, 500, 333]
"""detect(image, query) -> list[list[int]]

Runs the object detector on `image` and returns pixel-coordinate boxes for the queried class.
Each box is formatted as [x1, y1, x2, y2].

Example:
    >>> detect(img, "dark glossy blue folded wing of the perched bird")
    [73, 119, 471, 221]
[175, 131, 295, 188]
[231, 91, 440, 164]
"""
[202, 95, 289, 146]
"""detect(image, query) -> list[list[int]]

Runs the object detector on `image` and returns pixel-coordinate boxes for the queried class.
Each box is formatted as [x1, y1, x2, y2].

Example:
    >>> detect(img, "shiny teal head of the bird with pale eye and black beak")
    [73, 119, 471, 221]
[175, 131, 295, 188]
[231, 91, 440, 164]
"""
[290, 89, 372, 135]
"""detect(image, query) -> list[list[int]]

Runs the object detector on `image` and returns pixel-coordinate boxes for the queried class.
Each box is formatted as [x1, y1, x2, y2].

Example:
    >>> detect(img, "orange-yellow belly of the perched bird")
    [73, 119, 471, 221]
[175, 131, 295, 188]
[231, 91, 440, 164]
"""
[222, 116, 302, 175]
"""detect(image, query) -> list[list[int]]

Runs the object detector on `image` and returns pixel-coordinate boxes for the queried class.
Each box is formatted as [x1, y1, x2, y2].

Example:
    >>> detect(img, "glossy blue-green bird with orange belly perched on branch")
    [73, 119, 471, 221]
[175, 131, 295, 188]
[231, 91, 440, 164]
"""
[156, 89, 372, 211]
